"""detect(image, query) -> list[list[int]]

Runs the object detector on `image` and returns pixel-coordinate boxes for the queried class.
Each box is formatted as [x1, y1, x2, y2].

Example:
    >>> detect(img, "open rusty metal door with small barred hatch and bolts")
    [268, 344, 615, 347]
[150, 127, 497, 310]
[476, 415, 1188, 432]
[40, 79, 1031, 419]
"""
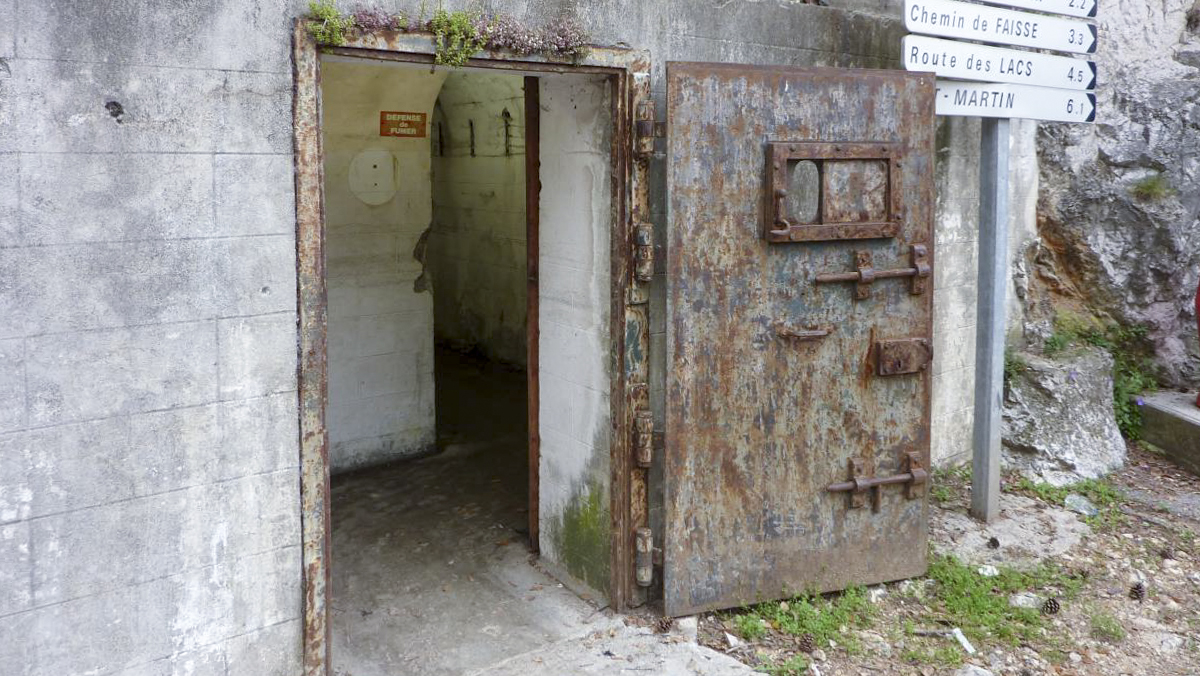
[664, 64, 934, 615]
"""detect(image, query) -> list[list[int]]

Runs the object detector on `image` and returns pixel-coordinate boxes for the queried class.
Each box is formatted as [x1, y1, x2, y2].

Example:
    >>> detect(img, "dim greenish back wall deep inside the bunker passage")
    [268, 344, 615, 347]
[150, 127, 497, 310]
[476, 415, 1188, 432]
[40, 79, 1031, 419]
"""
[427, 72, 527, 366]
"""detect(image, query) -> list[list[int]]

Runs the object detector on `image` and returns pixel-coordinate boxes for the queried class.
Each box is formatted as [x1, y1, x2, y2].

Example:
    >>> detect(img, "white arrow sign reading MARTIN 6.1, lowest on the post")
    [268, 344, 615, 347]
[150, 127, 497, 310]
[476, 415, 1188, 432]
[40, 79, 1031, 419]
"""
[937, 79, 1096, 122]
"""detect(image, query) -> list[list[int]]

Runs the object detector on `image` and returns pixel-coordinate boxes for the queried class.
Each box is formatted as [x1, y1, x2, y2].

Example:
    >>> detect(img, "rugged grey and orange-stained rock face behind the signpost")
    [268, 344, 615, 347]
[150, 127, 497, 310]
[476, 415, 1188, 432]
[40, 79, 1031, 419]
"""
[1014, 0, 1200, 385]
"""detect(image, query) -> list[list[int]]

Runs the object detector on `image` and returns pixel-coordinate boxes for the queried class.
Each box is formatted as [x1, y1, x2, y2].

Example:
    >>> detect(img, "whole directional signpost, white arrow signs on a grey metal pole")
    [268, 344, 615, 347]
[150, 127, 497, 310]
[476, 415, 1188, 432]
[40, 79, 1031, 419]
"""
[902, 0, 1098, 521]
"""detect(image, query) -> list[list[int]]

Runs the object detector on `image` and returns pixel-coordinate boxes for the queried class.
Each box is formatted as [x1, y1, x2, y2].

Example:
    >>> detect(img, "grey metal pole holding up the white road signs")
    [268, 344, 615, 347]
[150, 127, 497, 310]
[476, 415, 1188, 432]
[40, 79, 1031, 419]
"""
[971, 118, 1008, 521]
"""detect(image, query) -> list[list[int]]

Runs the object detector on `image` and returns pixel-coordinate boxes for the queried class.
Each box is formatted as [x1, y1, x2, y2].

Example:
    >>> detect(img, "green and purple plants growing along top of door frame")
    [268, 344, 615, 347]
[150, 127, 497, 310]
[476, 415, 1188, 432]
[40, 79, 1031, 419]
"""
[307, 0, 590, 67]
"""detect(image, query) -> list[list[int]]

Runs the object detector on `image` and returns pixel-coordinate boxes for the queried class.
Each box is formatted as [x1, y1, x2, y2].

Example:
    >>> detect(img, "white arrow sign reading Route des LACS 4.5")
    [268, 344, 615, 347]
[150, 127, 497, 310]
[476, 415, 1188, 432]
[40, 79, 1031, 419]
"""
[902, 35, 1096, 90]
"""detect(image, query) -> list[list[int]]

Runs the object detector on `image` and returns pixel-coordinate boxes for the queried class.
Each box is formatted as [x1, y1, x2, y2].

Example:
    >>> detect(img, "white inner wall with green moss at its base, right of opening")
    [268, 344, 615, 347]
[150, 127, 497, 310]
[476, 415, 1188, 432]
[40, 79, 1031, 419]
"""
[538, 76, 612, 590]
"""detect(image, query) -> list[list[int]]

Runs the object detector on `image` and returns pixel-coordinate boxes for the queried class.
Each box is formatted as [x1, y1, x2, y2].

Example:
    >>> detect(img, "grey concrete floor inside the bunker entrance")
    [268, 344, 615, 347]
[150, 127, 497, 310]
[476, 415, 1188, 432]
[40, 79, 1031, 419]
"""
[332, 352, 610, 676]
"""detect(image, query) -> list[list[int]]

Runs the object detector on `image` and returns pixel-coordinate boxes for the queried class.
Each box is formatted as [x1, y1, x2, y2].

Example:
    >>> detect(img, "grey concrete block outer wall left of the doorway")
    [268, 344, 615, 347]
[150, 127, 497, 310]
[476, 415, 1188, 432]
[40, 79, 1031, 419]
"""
[0, 0, 302, 676]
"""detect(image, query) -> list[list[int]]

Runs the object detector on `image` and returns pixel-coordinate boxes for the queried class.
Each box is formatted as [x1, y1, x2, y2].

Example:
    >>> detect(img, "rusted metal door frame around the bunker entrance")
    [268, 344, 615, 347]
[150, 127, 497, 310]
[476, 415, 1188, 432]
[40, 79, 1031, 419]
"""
[293, 19, 650, 676]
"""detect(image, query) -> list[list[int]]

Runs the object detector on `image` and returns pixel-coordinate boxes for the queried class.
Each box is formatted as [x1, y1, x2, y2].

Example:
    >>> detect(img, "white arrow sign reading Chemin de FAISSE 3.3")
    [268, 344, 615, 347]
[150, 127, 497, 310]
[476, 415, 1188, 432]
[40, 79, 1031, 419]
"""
[904, 0, 1096, 54]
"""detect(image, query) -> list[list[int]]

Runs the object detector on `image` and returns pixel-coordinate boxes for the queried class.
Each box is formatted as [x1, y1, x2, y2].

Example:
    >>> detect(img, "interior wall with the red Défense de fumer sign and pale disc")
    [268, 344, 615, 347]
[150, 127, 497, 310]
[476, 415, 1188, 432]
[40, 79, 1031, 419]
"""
[322, 60, 446, 472]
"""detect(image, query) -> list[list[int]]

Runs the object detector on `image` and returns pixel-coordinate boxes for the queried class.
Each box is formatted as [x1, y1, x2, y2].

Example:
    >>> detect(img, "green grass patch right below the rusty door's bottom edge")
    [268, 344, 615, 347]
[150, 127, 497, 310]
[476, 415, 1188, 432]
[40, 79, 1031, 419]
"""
[733, 587, 875, 654]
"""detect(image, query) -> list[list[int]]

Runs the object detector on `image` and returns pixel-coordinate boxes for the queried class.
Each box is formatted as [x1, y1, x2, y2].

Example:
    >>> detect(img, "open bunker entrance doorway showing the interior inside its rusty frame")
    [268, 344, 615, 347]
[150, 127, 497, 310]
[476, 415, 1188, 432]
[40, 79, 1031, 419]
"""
[320, 55, 612, 676]
